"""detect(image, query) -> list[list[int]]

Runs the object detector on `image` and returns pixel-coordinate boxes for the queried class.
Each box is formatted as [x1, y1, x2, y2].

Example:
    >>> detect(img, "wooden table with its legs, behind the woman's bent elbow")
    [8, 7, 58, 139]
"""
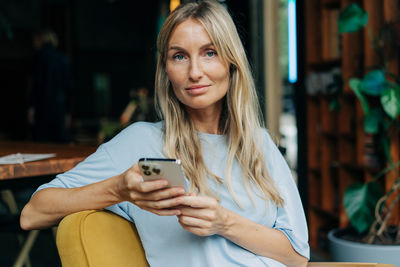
[0, 141, 96, 266]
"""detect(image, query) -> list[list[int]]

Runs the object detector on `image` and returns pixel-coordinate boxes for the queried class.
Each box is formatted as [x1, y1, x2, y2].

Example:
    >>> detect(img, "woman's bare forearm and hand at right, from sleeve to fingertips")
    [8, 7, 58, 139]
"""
[175, 194, 308, 266]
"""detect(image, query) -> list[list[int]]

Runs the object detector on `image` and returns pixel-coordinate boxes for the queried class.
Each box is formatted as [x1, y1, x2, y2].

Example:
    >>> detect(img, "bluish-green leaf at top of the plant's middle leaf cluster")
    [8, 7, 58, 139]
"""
[360, 70, 387, 96]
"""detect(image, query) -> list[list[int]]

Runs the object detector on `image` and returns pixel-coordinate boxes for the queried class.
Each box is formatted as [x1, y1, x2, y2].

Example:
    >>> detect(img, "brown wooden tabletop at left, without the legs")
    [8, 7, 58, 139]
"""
[0, 141, 96, 181]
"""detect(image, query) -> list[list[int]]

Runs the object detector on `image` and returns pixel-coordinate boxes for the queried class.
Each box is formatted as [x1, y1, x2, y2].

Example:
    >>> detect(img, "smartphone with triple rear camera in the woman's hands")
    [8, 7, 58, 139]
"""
[139, 158, 186, 188]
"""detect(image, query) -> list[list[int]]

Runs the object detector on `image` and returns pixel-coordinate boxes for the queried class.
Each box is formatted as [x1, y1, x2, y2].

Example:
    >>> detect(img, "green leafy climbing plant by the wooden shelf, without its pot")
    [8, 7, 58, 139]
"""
[338, 4, 400, 244]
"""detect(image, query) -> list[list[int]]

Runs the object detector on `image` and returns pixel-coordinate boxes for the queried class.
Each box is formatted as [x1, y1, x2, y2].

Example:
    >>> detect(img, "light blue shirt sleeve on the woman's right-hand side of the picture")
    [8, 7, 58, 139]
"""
[265, 131, 310, 259]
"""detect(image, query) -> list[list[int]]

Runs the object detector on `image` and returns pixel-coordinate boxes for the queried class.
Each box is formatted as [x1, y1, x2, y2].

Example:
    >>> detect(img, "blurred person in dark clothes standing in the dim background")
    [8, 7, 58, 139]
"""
[28, 29, 71, 143]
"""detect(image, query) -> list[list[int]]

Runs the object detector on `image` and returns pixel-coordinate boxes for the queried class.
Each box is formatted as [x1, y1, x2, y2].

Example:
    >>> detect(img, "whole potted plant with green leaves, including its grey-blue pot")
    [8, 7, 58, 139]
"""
[328, 4, 400, 266]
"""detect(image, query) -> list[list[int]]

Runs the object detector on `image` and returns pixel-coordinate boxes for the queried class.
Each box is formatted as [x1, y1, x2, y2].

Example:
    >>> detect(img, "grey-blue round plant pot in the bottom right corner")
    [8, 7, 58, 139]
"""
[328, 229, 400, 267]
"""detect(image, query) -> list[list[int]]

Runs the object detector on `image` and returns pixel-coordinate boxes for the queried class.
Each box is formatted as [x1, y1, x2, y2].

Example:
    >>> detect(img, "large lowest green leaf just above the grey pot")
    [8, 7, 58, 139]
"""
[343, 182, 383, 233]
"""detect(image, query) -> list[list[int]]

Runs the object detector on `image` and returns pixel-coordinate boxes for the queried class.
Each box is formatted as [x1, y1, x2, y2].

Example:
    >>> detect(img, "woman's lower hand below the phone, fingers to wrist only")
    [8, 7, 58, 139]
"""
[177, 194, 229, 236]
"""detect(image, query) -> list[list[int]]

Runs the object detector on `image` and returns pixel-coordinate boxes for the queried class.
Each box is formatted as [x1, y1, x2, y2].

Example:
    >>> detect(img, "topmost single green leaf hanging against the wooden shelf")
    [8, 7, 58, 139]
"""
[338, 3, 368, 33]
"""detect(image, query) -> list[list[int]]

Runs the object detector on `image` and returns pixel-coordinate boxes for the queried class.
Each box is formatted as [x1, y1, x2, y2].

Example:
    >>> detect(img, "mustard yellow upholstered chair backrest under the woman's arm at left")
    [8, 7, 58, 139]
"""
[57, 210, 149, 267]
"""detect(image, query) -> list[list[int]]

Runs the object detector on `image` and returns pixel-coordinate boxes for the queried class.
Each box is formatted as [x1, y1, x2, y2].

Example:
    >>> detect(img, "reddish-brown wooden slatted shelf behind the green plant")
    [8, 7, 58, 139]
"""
[305, 0, 400, 253]
